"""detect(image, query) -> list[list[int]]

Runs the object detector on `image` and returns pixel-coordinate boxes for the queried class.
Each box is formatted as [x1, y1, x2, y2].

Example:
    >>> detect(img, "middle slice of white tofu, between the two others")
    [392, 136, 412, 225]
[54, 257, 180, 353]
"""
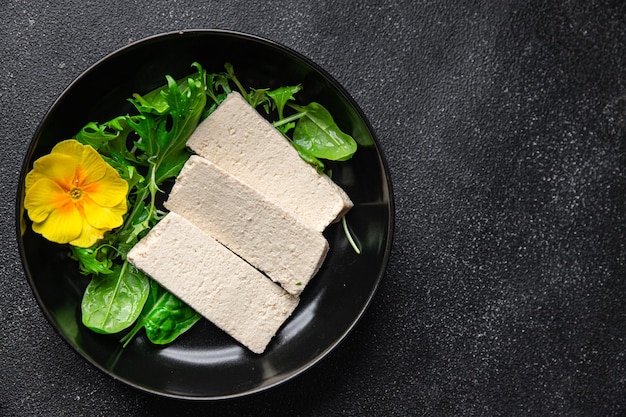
[165, 155, 328, 295]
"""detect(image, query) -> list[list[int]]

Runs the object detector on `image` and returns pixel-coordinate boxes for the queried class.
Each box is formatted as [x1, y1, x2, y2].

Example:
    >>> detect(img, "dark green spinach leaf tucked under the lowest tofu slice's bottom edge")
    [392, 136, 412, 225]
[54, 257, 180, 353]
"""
[121, 281, 201, 347]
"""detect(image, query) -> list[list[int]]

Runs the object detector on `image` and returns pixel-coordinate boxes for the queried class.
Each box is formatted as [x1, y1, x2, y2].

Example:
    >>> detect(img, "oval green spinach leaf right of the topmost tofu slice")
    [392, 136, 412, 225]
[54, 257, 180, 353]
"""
[293, 102, 357, 161]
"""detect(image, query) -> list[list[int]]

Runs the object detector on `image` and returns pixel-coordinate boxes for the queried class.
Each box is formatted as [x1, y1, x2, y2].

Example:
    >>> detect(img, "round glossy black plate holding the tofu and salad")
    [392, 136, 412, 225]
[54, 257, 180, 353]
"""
[17, 30, 393, 399]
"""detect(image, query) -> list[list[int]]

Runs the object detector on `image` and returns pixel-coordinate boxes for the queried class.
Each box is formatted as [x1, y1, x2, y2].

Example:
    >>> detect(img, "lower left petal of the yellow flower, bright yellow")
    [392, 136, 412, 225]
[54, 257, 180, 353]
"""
[33, 201, 83, 243]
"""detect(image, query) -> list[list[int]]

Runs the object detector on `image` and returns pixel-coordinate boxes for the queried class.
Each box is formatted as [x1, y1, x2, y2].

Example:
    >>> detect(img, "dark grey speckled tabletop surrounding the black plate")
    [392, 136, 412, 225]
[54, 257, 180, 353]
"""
[0, 0, 626, 417]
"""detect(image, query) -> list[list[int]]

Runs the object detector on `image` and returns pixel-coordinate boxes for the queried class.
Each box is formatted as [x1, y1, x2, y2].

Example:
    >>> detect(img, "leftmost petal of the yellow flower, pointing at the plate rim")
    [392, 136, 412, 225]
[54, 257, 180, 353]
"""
[24, 177, 71, 223]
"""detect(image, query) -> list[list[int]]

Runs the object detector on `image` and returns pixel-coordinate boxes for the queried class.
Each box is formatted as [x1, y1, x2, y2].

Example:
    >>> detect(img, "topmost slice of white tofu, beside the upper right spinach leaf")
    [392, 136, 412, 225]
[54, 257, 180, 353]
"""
[187, 92, 353, 232]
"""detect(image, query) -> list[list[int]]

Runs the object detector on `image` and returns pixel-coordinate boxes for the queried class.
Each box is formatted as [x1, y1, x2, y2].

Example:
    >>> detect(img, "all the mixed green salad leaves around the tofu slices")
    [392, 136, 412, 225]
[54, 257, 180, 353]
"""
[70, 63, 358, 346]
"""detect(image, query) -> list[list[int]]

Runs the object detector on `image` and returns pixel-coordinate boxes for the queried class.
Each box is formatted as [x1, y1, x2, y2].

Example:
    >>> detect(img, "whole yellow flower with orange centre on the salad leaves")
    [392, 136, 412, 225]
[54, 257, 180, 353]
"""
[24, 139, 128, 247]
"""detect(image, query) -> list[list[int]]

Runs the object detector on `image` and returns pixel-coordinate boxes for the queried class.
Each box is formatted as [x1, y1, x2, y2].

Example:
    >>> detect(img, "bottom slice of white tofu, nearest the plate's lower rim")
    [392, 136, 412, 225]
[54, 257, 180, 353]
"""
[128, 213, 299, 353]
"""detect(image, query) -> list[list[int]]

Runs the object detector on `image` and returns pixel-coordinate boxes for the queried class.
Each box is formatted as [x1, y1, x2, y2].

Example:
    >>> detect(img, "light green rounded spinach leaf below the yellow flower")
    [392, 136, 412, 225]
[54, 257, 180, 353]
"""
[81, 261, 150, 334]
